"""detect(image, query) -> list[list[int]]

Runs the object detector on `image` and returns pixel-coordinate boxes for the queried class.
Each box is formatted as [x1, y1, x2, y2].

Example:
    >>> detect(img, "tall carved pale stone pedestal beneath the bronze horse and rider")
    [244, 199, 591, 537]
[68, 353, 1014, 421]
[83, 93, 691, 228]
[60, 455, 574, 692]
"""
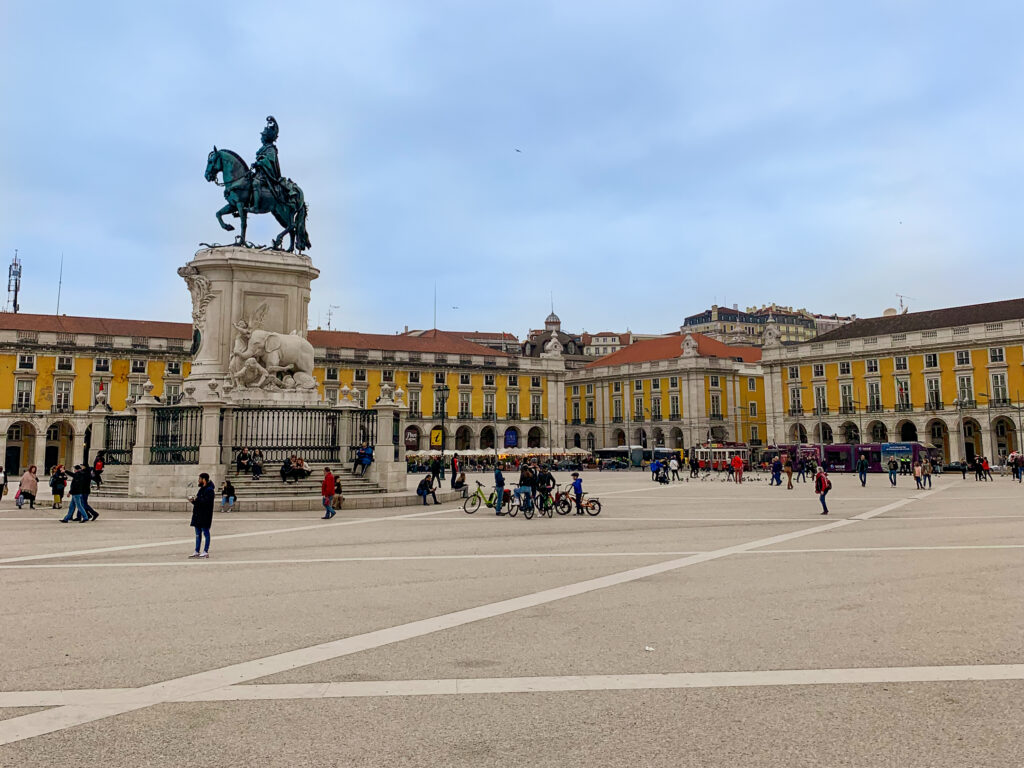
[178, 246, 319, 406]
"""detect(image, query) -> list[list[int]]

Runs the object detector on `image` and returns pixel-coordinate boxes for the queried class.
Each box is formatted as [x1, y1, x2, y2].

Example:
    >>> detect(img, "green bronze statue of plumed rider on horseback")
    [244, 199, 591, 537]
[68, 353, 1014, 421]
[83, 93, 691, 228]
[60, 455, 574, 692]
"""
[204, 117, 310, 252]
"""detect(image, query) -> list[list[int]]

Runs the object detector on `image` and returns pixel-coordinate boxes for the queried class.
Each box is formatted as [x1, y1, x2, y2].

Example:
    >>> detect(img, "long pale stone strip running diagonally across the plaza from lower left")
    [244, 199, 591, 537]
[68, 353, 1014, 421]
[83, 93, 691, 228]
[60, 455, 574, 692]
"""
[0, 488, 941, 745]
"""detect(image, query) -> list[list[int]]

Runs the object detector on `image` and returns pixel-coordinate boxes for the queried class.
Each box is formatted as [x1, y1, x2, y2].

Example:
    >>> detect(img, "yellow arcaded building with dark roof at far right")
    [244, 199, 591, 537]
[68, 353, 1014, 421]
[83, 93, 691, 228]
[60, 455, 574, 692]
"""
[763, 300, 1024, 461]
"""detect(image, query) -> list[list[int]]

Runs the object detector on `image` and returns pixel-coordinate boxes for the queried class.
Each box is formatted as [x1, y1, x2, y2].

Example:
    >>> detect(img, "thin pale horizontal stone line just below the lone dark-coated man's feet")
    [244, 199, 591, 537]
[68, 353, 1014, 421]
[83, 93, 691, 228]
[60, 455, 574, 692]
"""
[8, 544, 1024, 570]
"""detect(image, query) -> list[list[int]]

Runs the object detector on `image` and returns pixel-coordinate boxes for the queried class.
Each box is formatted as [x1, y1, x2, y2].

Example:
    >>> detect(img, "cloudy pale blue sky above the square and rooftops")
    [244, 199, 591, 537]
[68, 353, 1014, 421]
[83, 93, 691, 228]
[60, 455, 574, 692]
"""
[0, 0, 1024, 335]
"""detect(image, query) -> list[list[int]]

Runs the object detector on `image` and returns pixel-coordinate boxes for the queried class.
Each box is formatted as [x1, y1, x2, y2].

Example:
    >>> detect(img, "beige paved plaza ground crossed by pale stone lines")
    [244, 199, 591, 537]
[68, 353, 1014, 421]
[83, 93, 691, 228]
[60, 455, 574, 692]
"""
[0, 472, 1024, 768]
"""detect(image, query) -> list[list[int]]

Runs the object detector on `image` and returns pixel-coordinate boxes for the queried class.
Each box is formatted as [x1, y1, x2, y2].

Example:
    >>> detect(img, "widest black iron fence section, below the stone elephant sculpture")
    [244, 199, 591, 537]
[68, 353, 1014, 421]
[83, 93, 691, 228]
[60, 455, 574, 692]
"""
[231, 408, 342, 465]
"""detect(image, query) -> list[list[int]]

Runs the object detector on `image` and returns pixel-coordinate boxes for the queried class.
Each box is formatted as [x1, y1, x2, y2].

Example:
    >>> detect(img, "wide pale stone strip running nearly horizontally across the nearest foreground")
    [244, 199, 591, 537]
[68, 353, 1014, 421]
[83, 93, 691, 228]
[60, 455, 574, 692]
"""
[0, 664, 1024, 708]
